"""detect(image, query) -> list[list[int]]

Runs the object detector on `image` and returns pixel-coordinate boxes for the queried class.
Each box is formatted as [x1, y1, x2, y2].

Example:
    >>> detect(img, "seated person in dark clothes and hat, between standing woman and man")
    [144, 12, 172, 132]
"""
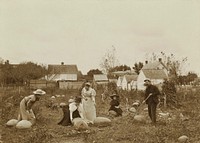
[108, 94, 123, 117]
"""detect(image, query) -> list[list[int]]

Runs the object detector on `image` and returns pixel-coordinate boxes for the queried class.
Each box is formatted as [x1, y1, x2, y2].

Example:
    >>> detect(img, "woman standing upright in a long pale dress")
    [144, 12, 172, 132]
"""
[81, 82, 96, 123]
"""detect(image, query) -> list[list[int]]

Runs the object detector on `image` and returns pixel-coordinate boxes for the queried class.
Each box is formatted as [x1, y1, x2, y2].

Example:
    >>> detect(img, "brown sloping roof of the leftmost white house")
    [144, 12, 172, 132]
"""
[48, 65, 79, 74]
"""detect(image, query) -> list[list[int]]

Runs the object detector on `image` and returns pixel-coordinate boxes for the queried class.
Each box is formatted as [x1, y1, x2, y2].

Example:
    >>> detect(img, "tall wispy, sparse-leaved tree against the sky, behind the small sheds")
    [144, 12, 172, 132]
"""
[100, 46, 118, 74]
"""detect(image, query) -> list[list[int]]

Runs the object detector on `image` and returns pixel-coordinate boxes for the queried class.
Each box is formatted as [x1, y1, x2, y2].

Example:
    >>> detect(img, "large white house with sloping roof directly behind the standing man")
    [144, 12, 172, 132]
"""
[137, 60, 168, 90]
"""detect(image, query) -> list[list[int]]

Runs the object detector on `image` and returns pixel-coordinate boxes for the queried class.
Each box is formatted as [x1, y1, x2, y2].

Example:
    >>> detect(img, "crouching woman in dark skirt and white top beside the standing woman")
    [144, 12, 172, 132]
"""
[58, 97, 84, 126]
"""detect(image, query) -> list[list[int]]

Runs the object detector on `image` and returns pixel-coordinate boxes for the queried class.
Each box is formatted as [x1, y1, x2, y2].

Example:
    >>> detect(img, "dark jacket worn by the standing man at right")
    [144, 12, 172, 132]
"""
[145, 85, 160, 104]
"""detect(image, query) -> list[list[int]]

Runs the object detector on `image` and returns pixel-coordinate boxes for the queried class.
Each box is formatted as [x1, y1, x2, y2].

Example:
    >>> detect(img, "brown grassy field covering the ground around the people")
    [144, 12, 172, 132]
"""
[0, 86, 200, 143]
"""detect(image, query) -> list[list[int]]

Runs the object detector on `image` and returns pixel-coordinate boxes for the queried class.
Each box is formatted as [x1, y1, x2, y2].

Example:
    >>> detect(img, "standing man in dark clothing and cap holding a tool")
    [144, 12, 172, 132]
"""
[144, 79, 160, 124]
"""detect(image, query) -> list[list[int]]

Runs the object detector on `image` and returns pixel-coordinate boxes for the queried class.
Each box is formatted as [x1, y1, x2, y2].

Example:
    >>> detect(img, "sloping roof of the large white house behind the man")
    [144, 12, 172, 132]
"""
[142, 69, 168, 79]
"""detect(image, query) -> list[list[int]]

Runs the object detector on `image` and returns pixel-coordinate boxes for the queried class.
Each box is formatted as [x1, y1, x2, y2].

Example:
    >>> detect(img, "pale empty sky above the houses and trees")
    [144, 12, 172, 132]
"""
[0, 0, 200, 74]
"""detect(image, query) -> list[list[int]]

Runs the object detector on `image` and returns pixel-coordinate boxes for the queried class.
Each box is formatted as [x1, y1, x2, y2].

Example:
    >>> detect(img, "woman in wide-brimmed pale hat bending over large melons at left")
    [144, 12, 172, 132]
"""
[18, 89, 46, 123]
